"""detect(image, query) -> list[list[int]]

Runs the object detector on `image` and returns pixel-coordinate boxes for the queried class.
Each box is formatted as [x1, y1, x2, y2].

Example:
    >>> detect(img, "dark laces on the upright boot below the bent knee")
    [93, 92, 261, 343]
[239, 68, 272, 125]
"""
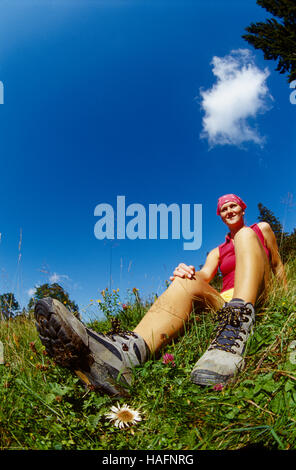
[209, 306, 252, 354]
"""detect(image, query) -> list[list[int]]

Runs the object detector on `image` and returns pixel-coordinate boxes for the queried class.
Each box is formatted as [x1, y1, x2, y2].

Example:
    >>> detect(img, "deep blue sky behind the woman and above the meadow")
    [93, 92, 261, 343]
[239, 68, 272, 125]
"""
[0, 0, 296, 316]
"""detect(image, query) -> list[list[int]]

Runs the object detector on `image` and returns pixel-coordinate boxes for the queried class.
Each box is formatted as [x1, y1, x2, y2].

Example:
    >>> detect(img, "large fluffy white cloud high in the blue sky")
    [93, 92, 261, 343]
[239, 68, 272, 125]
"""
[200, 49, 272, 147]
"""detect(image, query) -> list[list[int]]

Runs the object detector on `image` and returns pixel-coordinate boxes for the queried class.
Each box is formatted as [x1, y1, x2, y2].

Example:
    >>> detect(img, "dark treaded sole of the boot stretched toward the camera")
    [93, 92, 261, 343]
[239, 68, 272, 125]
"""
[35, 298, 129, 397]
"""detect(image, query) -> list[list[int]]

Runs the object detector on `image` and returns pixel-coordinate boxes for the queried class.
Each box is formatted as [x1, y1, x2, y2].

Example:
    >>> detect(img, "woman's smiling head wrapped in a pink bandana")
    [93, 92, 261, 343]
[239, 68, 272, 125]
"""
[217, 194, 247, 228]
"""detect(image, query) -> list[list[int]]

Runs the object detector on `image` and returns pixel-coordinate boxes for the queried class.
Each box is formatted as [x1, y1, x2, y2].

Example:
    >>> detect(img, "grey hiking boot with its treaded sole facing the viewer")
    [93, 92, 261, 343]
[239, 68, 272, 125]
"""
[35, 297, 148, 396]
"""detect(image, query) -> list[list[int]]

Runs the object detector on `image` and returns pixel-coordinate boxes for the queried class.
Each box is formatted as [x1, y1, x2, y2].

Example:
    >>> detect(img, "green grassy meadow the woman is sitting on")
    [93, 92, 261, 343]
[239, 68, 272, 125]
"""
[0, 262, 296, 451]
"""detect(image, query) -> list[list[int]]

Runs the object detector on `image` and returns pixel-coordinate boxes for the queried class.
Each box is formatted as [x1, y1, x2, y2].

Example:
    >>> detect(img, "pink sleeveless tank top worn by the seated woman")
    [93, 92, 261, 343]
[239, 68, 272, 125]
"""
[219, 224, 270, 292]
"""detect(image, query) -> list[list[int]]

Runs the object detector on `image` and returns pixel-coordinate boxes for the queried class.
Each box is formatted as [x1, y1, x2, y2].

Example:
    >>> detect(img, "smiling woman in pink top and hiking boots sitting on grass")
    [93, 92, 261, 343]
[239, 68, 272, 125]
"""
[35, 194, 286, 395]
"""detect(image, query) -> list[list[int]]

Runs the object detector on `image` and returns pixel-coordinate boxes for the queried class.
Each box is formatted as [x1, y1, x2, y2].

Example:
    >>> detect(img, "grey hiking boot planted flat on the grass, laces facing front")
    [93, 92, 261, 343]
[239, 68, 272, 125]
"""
[190, 300, 255, 385]
